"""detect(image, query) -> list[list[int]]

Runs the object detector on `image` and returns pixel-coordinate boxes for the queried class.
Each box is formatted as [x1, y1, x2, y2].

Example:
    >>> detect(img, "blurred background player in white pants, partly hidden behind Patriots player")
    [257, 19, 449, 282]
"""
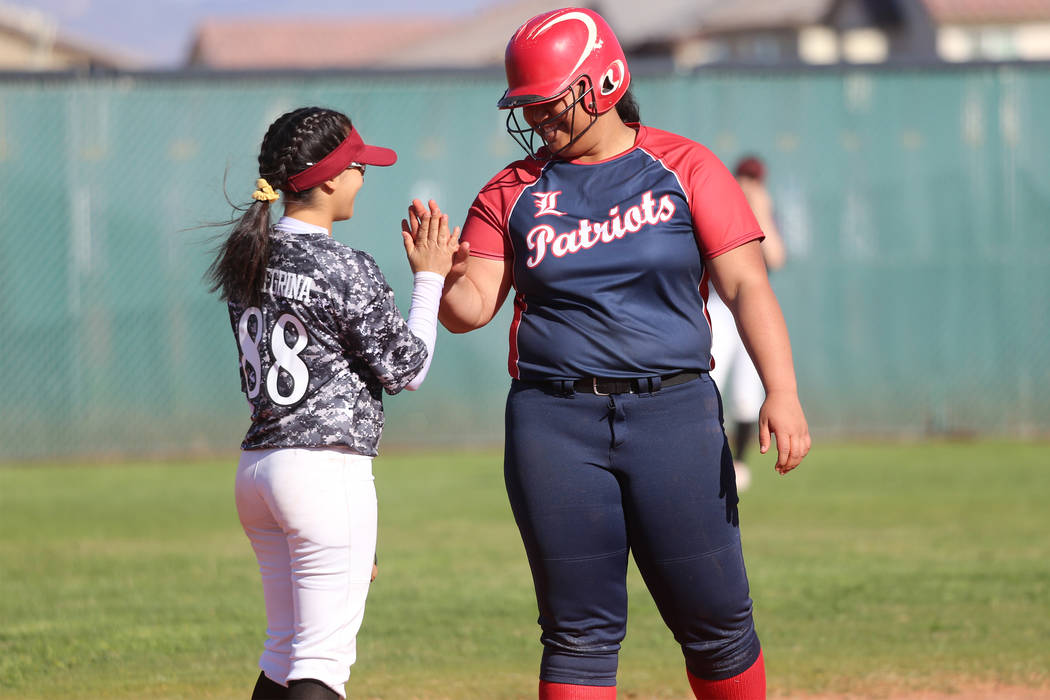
[708, 155, 786, 491]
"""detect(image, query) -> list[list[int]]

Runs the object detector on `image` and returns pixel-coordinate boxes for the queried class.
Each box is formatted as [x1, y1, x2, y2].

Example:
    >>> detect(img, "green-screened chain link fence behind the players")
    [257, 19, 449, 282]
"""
[0, 65, 1050, 460]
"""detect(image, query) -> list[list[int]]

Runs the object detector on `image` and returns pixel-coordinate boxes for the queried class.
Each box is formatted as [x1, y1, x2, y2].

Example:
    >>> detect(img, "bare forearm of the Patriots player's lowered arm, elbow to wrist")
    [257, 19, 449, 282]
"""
[731, 280, 798, 395]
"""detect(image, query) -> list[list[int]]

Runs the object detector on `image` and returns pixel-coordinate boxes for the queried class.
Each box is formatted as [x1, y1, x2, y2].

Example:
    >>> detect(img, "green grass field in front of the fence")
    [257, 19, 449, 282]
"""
[0, 442, 1050, 700]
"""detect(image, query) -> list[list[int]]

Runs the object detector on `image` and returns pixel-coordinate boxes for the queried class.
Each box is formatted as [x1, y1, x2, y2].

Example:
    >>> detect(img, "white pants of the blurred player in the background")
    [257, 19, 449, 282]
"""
[708, 290, 765, 423]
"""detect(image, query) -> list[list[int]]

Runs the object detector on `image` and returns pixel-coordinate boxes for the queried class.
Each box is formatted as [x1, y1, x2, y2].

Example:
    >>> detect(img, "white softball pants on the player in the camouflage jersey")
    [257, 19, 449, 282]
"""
[235, 448, 376, 697]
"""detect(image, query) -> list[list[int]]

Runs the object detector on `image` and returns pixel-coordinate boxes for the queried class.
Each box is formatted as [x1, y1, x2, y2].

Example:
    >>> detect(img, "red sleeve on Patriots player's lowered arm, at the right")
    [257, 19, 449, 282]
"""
[645, 129, 765, 258]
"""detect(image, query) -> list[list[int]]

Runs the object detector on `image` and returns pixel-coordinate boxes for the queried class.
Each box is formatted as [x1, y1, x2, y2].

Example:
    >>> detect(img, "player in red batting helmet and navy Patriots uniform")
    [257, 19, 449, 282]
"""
[422, 7, 810, 700]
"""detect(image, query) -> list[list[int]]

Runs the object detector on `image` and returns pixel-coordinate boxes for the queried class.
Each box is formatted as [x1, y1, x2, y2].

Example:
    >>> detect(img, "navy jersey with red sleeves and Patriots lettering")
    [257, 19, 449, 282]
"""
[462, 126, 762, 380]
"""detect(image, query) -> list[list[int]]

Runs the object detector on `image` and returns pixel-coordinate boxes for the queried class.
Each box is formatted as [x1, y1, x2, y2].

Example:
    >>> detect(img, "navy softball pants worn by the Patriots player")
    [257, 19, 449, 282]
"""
[504, 374, 759, 686]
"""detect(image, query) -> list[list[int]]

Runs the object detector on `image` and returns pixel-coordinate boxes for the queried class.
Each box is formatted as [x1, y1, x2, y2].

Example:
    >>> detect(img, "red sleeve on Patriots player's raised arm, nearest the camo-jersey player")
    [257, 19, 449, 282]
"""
[460, 160, 543, 260]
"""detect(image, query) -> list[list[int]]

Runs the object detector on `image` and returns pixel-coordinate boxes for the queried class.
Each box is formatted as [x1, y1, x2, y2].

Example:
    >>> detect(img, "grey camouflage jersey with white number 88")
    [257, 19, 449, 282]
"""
[229, 228, 426, 457]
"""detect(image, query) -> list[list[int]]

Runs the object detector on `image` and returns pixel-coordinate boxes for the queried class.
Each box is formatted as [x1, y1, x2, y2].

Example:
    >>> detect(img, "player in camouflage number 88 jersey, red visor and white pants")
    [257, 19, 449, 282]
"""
[209, 107, 459, 700]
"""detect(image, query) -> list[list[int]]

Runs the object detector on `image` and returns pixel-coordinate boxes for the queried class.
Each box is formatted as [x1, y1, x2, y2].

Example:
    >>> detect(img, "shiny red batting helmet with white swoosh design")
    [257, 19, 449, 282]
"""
[499, 7, 631, 114]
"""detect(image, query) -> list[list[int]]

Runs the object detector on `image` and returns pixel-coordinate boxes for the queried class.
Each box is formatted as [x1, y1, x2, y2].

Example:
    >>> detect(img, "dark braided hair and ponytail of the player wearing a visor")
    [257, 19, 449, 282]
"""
[206, 107, 352, 305]
